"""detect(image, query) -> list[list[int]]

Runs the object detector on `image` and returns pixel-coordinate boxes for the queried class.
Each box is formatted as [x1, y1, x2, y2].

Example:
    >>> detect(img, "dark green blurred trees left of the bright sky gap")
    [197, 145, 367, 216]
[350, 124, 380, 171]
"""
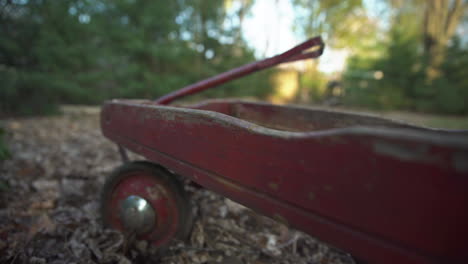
[0, 0, 271, 115]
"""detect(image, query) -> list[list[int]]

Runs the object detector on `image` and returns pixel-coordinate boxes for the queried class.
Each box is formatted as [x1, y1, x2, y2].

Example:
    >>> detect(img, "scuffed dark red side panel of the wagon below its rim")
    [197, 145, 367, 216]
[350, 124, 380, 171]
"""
[99, 98, 468, 263]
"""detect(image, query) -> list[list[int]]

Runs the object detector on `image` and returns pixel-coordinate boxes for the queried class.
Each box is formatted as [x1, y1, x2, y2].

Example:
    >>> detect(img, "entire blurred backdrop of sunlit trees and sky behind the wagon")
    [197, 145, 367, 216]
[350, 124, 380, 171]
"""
[0, 0, 468, 119]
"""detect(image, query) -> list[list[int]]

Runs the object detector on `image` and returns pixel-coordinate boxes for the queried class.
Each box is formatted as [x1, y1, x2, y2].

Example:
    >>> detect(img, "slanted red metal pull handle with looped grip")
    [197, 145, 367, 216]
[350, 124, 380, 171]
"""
[155, 37, 325, 105]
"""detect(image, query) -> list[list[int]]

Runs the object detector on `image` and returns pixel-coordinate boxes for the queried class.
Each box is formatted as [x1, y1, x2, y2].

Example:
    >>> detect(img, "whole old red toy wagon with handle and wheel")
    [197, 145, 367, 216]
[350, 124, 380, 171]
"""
[101, 38, 468, 264]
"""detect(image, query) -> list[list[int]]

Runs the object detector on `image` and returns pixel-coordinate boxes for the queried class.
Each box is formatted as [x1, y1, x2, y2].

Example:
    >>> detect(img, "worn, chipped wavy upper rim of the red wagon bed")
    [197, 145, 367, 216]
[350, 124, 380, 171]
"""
[104, 100, 468, 144]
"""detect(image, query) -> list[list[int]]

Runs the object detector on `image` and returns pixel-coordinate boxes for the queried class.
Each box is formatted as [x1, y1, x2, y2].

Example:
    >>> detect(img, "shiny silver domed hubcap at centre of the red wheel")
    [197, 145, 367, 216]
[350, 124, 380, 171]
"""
[120, 195, 156, 235]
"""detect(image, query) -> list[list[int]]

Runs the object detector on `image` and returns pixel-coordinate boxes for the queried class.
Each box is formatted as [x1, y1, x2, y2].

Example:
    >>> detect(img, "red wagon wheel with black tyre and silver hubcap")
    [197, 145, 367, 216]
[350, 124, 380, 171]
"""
[101, 162, 192, 247]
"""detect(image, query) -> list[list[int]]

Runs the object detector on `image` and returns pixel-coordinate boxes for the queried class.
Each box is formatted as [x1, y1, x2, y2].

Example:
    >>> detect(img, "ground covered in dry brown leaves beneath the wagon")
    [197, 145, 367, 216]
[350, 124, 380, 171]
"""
[0, 109, 354, 264]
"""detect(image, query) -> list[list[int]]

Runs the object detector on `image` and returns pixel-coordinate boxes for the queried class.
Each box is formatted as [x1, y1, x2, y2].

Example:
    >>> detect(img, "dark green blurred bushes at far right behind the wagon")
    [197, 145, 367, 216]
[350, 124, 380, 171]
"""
[344, 27, 468, 114]
